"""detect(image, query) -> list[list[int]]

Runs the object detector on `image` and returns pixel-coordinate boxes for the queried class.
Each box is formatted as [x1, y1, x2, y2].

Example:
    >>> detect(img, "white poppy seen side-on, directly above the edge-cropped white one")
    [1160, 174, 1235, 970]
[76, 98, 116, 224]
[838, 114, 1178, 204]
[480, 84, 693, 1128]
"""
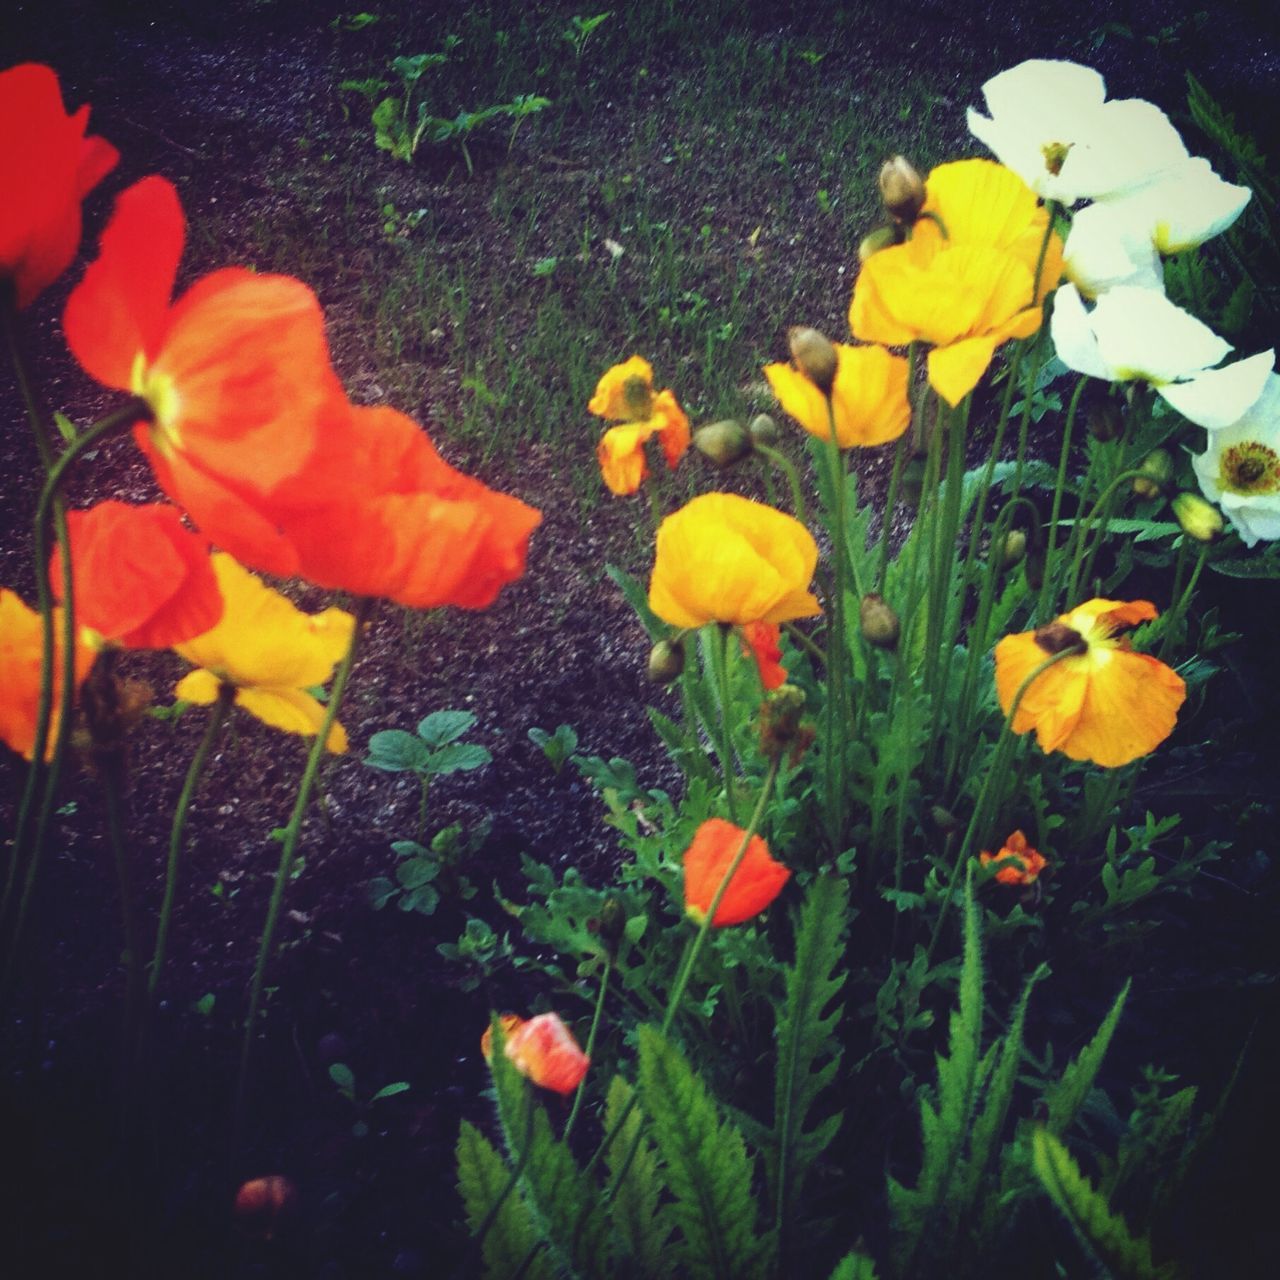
[1050, 284, 1275, 429]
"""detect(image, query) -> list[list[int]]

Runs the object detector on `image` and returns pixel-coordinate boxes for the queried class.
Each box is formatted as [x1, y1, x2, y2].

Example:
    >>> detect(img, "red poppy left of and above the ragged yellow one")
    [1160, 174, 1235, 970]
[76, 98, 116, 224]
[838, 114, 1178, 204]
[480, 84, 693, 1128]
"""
[49, 502, 223, 649]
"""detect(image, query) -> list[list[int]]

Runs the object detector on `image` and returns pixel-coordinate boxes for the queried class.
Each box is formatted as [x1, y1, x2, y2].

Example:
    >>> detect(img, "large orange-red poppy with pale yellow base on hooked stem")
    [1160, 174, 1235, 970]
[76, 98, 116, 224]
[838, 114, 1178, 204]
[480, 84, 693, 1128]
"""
[63, 178, 349, 576]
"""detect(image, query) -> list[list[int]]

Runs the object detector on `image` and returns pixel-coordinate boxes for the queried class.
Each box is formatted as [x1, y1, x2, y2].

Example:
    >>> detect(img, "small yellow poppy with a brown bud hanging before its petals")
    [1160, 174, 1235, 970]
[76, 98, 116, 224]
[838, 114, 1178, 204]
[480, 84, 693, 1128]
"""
[764, 342, 911, 449]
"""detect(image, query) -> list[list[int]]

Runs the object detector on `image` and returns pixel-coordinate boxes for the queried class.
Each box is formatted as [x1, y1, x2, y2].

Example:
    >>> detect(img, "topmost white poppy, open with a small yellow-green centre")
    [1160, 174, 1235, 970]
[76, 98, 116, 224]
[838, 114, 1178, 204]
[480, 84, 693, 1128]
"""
[968, 58, 1187, 205]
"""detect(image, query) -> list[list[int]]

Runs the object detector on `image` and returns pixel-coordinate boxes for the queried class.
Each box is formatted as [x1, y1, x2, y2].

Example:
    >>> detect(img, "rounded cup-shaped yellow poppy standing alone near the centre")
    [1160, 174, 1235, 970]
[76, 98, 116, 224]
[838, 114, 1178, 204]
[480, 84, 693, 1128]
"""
[649, 493, 822, 627]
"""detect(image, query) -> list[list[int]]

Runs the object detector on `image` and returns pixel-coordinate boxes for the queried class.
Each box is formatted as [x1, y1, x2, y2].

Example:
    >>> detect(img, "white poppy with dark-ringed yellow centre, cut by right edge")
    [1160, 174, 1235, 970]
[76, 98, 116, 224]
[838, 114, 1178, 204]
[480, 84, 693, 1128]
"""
[1192, 374, 1280, 547]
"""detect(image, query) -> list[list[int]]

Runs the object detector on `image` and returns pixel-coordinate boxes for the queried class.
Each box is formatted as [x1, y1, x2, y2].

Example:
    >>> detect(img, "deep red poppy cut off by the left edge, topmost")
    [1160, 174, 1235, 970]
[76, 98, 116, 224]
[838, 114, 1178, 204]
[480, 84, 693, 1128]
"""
[0, 63, 119, 308]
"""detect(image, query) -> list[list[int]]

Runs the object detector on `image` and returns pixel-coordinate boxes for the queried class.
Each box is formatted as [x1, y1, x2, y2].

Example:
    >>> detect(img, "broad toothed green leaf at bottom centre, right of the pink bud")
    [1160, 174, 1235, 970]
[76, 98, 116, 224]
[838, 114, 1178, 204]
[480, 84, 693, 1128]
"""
[637, 1027, 769, 1280]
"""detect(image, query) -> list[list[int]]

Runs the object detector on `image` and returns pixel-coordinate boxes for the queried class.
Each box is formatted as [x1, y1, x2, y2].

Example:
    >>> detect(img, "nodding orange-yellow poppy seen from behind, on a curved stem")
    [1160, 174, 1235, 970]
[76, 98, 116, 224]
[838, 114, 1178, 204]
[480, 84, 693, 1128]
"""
[996, 600, 1187, 768]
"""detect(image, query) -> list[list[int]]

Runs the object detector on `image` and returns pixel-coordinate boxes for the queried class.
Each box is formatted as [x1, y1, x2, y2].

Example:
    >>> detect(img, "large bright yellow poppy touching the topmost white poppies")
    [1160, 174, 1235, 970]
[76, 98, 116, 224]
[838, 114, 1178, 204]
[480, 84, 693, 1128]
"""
[849, 160, 1062, 404]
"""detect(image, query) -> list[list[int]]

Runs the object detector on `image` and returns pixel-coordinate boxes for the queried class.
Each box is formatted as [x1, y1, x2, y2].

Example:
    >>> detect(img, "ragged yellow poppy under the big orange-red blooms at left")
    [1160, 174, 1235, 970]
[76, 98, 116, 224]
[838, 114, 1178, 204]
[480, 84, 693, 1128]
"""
[174, 552, 355, 753]
